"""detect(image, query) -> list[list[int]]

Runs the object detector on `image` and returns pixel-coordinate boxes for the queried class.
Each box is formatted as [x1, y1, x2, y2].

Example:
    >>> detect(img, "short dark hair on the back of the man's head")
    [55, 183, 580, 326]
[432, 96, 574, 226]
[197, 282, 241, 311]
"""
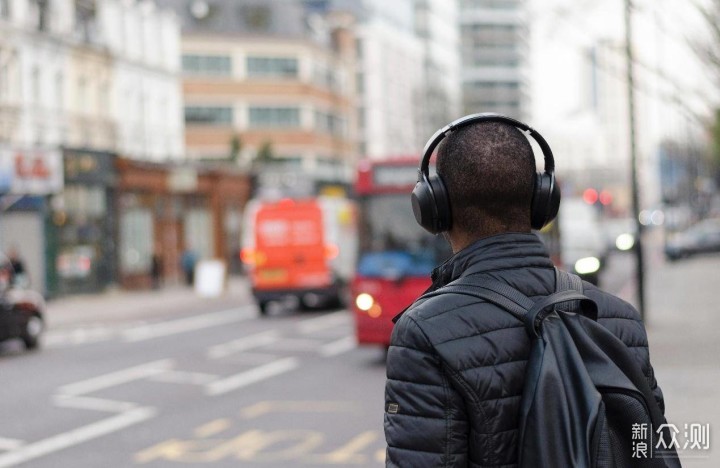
[437, 122, 536, 233]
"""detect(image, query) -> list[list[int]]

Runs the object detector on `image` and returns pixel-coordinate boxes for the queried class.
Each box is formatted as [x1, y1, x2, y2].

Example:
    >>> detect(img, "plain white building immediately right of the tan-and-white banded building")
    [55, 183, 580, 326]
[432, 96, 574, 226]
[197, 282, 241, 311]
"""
[332, 0, 427, 159]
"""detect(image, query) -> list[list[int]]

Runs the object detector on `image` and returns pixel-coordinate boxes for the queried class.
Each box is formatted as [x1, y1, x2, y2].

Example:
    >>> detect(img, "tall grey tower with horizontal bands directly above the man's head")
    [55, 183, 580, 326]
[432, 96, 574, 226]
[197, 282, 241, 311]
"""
[459, 0, 529, 119]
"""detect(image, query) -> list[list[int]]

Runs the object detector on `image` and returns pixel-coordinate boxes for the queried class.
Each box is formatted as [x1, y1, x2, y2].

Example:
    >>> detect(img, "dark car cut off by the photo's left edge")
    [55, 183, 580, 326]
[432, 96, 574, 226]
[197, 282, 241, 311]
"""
[0, 269, 45, 349]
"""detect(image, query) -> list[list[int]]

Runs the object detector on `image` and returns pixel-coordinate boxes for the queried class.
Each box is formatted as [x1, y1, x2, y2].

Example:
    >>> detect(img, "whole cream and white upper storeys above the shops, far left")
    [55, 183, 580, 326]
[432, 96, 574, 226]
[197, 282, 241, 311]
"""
[0, 0, 183, 160]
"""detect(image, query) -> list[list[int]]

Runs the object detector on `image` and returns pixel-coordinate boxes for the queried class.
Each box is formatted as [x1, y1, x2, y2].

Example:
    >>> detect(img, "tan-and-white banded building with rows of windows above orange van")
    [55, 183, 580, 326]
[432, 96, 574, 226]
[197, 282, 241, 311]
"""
[163, 0, 357, 191]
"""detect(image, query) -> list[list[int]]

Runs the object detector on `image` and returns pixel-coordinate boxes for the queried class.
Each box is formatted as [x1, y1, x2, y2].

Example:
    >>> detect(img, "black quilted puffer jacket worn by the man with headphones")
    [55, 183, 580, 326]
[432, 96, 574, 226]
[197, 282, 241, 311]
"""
[385, 233, 664, 468]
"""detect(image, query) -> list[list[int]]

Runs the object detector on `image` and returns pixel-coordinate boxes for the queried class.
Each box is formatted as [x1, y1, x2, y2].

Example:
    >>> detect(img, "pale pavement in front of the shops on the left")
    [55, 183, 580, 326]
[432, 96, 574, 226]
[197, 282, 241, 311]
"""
[46, 276, 252, 330]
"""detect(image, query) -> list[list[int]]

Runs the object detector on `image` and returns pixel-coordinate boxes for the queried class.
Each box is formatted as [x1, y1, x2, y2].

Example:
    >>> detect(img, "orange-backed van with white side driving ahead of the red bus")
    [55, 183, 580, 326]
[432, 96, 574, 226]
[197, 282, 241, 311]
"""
[242, 197, 357, 314]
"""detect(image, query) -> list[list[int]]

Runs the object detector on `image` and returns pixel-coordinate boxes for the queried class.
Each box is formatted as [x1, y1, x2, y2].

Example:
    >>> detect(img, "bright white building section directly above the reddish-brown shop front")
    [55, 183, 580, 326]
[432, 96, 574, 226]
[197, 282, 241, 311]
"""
[97, 0, 184, 161]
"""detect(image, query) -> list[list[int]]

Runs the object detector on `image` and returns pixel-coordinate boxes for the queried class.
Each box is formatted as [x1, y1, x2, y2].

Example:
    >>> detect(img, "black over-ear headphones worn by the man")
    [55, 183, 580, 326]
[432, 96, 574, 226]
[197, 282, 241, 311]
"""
[411, 113, 560, 234]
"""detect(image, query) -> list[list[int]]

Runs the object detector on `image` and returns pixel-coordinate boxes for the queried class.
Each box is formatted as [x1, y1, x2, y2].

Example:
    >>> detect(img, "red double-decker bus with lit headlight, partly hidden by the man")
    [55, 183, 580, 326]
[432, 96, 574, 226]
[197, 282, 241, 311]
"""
[351, 157, 451, 346]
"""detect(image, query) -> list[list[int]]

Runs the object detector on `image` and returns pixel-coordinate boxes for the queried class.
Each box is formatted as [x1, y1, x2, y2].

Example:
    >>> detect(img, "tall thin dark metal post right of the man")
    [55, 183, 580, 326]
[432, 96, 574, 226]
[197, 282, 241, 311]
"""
[625, 0, 645, 320]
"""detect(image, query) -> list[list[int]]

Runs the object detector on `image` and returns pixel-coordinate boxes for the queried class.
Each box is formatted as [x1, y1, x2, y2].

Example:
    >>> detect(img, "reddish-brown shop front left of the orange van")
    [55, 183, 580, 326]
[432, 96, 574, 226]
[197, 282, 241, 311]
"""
[117, 159, 250, 288]
